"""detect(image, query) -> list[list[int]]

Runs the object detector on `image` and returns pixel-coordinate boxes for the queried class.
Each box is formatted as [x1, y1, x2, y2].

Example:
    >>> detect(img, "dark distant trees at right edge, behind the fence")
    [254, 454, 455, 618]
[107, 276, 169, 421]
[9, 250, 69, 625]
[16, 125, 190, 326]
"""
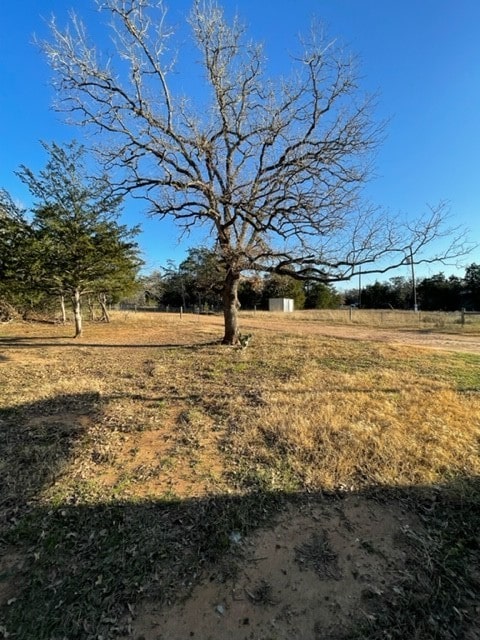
[345, 263, 480, 311]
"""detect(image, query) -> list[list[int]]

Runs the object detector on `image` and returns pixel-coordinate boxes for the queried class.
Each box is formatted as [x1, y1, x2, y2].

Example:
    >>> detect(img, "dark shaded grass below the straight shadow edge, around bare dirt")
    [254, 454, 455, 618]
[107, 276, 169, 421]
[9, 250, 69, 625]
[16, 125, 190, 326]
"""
[4, 480, 480, 640]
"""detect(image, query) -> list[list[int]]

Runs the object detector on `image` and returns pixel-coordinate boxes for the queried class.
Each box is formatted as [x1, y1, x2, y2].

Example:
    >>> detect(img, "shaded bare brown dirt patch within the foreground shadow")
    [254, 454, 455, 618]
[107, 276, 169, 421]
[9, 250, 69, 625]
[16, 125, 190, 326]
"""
[132, 495, 420, 640]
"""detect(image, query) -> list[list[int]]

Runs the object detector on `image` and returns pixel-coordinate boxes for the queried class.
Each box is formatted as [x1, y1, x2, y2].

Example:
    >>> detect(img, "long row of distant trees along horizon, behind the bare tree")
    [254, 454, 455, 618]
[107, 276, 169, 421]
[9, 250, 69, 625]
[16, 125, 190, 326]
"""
[133, 246, 480, 312]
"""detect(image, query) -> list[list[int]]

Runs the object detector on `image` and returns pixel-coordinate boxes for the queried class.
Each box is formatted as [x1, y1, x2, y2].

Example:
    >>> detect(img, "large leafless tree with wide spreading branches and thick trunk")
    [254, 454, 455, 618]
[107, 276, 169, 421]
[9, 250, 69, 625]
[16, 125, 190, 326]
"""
[43, 0, 470, 344]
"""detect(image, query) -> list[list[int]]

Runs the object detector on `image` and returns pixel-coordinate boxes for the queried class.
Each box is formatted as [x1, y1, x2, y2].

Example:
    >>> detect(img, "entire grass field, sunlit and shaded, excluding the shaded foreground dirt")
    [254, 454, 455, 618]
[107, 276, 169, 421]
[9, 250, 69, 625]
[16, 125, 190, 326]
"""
[0, 312, 480, 640]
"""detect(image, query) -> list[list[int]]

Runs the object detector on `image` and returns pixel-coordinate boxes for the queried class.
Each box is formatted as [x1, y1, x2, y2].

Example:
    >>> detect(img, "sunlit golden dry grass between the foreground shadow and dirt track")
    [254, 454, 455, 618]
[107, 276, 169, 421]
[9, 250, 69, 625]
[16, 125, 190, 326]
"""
[0, 313, 480, 500]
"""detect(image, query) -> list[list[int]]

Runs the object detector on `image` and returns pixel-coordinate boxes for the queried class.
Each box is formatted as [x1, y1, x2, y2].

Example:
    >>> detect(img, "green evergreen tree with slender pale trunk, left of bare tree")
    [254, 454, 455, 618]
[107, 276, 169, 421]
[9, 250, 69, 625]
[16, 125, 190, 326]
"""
[8, 142, 141, 335]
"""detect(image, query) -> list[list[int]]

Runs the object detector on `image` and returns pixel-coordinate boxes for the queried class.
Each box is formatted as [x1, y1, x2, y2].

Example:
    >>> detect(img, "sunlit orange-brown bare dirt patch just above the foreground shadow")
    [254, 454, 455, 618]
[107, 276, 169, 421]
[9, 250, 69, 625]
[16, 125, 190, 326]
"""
[82, 405, 224, 500]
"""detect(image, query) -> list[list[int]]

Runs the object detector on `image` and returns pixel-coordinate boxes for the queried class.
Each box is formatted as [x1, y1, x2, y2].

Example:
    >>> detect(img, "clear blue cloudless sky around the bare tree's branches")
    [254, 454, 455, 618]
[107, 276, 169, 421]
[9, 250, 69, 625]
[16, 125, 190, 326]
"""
[0, 0, 480, 280]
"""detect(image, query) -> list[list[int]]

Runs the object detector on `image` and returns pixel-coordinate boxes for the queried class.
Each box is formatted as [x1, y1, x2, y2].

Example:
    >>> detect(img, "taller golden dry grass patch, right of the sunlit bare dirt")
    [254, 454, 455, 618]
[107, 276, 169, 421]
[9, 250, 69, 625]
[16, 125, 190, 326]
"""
[223, 338, 480, 489]
